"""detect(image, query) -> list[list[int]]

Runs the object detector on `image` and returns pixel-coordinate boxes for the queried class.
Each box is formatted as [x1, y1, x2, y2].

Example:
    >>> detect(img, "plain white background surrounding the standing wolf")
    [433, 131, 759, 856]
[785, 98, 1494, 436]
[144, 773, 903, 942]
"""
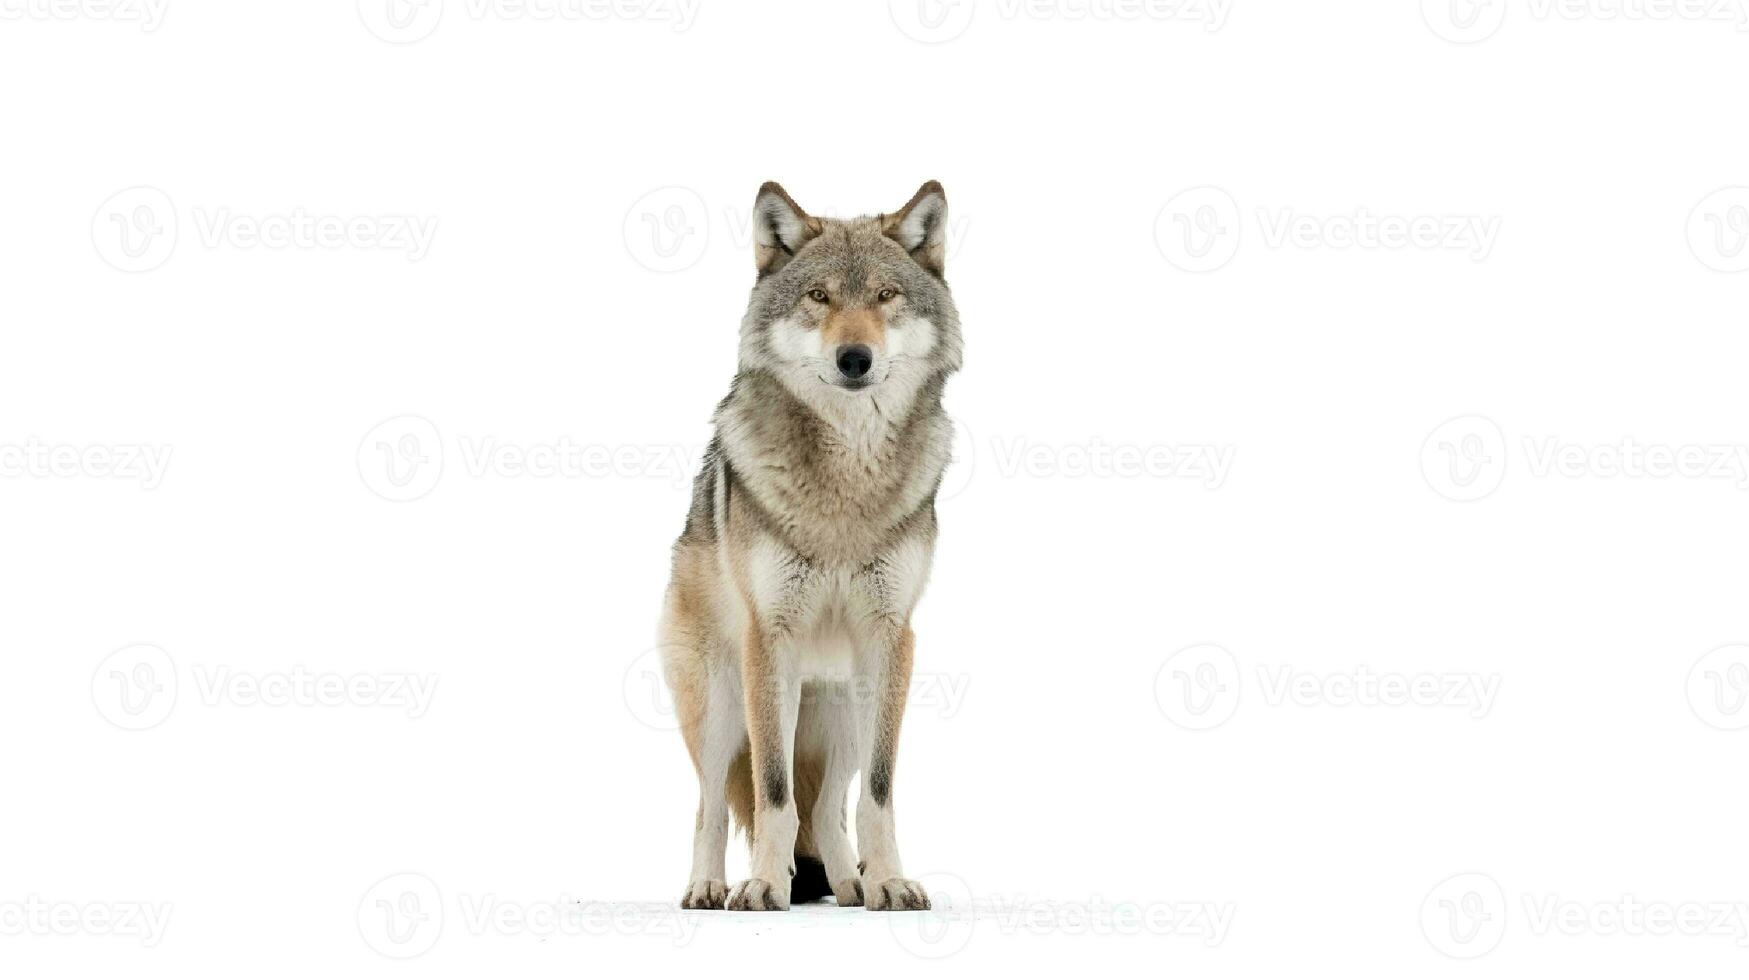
[0, 0, 1749, 978]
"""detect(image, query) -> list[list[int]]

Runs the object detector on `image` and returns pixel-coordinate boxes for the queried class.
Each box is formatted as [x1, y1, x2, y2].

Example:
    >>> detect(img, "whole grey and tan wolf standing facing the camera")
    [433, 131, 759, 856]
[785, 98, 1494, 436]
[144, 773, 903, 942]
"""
[659, 180, 960, 912]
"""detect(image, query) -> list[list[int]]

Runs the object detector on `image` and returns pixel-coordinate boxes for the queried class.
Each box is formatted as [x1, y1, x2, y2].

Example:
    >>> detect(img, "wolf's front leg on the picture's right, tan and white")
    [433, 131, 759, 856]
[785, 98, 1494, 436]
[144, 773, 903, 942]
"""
[857, 627, 929, 912]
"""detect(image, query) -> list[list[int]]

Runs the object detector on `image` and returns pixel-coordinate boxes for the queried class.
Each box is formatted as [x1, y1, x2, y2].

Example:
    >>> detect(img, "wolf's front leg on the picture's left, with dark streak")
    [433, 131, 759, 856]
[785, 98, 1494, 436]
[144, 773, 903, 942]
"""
[728, 623, 801, 912]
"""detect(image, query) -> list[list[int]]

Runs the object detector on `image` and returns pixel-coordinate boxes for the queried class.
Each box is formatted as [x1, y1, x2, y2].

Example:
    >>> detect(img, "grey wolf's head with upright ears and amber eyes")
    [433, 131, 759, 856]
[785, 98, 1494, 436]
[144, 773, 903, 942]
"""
[740, 180, 960, 413]
